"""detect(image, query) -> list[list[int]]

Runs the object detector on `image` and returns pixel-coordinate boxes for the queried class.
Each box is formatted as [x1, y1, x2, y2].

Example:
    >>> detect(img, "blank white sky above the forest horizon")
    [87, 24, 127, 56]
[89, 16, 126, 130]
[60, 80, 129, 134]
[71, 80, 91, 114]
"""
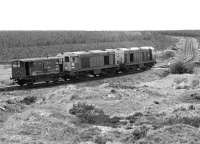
[0, 0, 200, 30]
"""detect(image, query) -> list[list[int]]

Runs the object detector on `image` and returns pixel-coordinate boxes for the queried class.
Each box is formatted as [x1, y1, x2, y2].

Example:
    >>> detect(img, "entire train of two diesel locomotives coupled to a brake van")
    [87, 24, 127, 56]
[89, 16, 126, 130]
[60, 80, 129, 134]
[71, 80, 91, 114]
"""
[11, 47, 156, 86]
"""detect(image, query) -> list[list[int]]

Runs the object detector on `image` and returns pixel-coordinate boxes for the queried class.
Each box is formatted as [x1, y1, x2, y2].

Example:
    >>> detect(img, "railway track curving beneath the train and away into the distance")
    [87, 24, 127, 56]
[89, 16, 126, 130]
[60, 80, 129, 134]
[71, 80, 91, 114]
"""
[0, 38, 198, 91]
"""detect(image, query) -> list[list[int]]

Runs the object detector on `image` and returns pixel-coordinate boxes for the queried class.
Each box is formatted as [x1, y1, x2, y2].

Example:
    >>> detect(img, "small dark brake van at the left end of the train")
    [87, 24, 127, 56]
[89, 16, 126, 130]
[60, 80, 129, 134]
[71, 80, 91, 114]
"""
[11, 57, 60, 86]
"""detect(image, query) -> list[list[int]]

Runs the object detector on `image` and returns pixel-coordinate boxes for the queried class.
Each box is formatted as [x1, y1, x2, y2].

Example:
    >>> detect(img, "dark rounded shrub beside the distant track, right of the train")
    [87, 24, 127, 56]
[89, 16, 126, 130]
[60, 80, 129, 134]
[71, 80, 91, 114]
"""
[169, 61, 194, 74]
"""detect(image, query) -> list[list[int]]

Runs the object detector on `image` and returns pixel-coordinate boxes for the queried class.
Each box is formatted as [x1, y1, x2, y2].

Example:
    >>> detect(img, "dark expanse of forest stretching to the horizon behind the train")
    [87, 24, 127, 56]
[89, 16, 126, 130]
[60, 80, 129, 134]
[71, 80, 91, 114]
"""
[0, 30, 200, 62]
